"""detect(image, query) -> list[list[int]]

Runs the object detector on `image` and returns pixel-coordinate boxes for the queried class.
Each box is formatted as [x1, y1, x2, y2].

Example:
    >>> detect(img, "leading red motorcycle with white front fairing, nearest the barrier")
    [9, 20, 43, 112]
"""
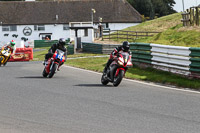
[101, 52, 132, 86]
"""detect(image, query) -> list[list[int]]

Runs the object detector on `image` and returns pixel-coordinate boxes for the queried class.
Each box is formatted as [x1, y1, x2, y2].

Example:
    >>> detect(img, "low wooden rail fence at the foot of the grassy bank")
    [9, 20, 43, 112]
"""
[102, 30, 160, 41]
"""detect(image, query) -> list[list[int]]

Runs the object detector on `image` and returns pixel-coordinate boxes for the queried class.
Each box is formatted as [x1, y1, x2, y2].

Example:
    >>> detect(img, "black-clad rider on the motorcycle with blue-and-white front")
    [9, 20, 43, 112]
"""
[43, 38, 67, 71]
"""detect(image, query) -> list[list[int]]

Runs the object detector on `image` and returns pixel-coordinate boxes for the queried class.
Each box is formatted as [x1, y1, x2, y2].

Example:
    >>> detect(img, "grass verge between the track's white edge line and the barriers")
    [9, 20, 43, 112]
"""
[66, 57, 200, 90]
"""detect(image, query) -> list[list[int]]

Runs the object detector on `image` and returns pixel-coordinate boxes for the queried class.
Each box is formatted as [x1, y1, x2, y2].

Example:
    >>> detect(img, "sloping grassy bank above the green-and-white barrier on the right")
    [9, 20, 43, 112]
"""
[112, 13, 200, 47]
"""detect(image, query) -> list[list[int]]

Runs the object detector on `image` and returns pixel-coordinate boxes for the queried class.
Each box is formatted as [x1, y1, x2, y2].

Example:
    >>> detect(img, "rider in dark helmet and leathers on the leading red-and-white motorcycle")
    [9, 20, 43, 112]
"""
[104, 41, 131, 72]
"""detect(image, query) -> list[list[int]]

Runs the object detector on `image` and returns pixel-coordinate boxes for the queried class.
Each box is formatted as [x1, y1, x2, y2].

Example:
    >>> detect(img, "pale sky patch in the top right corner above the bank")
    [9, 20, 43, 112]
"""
[174, 0, 200, 12]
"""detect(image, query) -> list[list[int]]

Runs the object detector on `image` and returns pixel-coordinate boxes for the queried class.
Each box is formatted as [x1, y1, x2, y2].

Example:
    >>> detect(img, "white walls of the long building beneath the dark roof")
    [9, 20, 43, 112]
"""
[0, 23, 139, 47]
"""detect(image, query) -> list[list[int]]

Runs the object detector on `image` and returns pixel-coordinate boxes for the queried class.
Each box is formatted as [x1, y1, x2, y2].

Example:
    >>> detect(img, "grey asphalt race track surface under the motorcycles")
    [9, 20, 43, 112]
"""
[0, 62, 200, 133]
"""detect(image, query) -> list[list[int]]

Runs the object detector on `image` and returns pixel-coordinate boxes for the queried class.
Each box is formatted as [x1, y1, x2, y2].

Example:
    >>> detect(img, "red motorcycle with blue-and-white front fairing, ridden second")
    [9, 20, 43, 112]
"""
[42, 49, 65, 78]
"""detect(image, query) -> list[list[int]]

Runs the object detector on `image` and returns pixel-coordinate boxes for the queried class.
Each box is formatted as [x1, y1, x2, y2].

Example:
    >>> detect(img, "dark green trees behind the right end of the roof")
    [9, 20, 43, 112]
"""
[127, 0, 176, 19]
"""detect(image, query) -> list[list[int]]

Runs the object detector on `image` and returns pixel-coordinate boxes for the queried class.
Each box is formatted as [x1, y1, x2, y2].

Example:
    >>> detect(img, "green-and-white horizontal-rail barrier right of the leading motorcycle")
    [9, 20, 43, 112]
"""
[131, 43, 200, 78]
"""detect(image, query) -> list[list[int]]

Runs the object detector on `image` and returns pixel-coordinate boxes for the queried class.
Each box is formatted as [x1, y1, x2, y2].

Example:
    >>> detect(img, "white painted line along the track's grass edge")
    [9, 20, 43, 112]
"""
[63, 65, 200, 94]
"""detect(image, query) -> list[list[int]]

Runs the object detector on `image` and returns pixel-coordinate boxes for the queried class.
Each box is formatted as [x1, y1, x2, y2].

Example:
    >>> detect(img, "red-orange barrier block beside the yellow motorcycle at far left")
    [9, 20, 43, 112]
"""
[9, 48, 33, 61]
